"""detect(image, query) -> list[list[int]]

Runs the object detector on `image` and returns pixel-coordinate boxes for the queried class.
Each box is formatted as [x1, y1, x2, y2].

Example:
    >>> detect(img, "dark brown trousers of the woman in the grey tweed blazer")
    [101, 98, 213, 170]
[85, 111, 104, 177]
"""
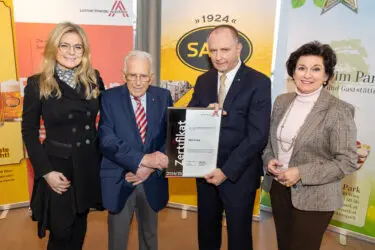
[270, 180, 333, 250]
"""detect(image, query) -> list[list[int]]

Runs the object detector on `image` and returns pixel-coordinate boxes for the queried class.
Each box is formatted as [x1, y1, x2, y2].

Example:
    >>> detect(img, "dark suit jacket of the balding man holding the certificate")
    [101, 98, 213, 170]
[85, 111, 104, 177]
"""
[189, 64, 271, 191]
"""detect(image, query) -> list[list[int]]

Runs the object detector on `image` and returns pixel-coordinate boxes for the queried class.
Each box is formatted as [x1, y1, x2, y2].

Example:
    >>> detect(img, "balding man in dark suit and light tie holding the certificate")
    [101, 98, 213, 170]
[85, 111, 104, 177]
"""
[189, 25, 271, 250]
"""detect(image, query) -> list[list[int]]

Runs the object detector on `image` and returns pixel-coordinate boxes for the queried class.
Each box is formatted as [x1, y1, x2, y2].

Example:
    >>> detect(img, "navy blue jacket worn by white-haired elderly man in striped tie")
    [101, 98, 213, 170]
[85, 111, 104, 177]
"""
[99, 85, 173, 213]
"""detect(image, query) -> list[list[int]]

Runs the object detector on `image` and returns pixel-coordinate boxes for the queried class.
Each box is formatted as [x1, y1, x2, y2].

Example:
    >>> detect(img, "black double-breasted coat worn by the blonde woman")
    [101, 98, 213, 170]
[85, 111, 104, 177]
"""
[22, 73, 104, 237]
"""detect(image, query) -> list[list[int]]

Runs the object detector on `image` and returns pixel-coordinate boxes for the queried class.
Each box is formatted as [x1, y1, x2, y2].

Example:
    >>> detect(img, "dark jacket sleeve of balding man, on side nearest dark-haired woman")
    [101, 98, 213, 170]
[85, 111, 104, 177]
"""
[222, 76, 271, 182]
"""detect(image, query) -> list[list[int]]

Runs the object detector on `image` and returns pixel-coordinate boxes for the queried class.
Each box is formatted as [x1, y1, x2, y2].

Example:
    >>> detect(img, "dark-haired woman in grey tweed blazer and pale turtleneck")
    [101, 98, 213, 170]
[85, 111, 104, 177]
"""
[263, 41, 357, 250]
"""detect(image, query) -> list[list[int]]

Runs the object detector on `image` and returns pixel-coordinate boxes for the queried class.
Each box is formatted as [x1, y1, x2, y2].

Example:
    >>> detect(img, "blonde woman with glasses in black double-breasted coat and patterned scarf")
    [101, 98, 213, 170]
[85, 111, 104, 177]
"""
[22, 22, 104, 250]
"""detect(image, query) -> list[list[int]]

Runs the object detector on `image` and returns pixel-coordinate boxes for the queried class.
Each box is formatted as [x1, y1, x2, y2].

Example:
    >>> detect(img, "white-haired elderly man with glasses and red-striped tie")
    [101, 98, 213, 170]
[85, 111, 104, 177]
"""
[99, 51, 172, 250]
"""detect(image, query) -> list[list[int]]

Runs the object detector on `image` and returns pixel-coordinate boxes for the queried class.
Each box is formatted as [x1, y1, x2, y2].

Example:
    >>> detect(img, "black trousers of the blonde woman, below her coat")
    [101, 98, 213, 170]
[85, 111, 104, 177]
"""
[47, 191, 88, 250]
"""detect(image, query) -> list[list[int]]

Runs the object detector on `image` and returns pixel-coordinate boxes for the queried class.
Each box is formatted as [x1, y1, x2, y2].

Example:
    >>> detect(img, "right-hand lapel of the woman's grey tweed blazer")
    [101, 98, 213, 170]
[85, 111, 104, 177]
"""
[291, 89, 331, 159]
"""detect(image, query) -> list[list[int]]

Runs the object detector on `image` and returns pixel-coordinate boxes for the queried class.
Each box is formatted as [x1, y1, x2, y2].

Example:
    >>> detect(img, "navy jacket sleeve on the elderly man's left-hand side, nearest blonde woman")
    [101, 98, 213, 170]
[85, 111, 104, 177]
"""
[98, 94, 144, 173]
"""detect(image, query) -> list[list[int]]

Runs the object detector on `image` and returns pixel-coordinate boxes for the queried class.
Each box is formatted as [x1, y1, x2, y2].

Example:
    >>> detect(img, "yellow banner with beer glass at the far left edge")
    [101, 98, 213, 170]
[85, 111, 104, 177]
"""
[0, 0, 29, 207]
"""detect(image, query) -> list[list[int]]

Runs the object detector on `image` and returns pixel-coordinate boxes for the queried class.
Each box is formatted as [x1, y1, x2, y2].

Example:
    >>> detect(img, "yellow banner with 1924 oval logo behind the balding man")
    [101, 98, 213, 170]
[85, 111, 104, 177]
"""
[160, 0, 276, 216]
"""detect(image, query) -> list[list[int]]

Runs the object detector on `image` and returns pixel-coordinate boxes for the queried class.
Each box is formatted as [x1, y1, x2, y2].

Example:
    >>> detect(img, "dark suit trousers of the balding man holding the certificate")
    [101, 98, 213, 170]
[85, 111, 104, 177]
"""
[197, 179, 255, 250]
